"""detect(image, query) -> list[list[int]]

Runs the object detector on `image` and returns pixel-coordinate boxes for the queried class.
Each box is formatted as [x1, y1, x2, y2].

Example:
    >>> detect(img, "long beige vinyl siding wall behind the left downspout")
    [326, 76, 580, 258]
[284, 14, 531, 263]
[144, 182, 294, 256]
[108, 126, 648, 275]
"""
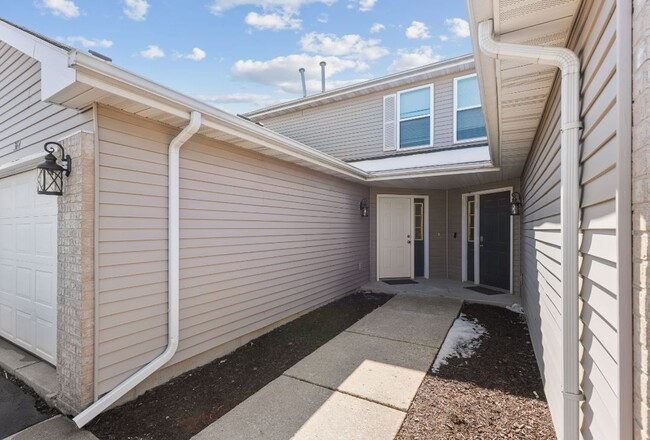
[97, 107, 369, 394]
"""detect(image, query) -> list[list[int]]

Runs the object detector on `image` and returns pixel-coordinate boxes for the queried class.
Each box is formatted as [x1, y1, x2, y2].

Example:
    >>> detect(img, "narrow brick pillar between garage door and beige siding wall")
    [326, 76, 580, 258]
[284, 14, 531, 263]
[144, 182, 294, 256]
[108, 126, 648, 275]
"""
[57, 131, 95, 414]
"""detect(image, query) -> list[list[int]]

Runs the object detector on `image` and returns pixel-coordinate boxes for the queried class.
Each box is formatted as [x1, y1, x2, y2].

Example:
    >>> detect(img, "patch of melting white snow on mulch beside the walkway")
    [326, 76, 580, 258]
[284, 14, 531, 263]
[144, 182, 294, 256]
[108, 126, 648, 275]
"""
[431, 313, 487, 373]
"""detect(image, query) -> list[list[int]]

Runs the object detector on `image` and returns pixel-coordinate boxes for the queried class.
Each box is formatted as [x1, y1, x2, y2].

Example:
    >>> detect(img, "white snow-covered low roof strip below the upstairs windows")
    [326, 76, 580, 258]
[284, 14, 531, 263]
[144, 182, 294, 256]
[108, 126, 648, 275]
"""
[348, 145, 490, 173]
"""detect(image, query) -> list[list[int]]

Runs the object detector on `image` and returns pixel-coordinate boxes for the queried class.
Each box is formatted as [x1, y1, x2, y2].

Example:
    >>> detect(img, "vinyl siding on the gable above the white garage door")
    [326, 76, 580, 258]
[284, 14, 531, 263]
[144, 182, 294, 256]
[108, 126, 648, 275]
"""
[0, 42, 92, 165]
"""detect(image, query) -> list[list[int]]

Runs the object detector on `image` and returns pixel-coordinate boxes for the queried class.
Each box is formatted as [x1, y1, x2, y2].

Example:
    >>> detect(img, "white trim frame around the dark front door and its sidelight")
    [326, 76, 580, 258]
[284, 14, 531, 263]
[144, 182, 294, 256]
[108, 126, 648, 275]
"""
[461, 186, 515, 293]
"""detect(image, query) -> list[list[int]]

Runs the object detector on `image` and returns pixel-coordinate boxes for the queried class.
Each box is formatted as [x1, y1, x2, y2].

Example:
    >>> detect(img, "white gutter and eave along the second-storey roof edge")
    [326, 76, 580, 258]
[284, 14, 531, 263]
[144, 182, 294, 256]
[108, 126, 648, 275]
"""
[244, 54, 474, 121]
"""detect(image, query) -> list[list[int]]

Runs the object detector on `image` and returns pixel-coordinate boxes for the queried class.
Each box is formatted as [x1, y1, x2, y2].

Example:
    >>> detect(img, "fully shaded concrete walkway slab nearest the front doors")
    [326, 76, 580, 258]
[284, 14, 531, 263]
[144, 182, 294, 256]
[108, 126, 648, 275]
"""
[347, 295, 462, 348]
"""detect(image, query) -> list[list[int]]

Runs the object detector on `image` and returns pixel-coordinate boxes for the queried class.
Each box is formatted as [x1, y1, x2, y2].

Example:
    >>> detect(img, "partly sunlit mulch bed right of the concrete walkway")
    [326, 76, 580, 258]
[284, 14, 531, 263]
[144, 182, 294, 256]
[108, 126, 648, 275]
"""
[397, 304, 556, 440]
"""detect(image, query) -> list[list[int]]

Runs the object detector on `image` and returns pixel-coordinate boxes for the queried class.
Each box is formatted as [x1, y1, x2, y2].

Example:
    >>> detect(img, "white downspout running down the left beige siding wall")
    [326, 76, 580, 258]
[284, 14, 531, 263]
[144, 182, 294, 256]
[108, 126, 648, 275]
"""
[72, 112, 201, 428]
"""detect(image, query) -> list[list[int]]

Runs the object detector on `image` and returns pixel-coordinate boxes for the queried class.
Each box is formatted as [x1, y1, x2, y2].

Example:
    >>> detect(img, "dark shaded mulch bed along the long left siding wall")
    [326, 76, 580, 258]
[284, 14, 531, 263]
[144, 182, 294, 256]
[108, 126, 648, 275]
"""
[85, 294, 392, 440]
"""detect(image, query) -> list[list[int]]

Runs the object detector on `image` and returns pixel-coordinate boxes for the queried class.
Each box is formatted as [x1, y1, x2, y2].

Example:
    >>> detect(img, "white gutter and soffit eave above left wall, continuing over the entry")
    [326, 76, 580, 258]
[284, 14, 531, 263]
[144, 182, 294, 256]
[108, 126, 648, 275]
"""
[0, 20, 500, 187]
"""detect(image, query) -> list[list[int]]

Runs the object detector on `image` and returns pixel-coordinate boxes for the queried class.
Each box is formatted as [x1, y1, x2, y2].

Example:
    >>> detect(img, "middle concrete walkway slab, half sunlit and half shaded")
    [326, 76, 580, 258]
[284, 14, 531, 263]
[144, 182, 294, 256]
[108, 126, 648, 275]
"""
[285, 332, 437, 411]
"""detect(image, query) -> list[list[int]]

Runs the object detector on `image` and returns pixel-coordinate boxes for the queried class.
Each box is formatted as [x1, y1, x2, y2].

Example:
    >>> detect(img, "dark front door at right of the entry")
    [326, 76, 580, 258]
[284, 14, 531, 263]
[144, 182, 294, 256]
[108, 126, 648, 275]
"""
[479, 191, 510, 289]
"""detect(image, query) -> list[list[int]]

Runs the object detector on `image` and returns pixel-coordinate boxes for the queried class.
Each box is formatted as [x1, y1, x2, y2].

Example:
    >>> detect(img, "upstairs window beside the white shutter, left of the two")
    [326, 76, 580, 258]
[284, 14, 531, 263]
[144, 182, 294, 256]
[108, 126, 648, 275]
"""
[397, 86, 433, 148]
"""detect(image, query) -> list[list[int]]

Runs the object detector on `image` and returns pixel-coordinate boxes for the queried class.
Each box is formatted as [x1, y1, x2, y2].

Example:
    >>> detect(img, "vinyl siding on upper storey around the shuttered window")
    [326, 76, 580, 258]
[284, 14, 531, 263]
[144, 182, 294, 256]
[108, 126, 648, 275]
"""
[262, 70, 474, 160]
